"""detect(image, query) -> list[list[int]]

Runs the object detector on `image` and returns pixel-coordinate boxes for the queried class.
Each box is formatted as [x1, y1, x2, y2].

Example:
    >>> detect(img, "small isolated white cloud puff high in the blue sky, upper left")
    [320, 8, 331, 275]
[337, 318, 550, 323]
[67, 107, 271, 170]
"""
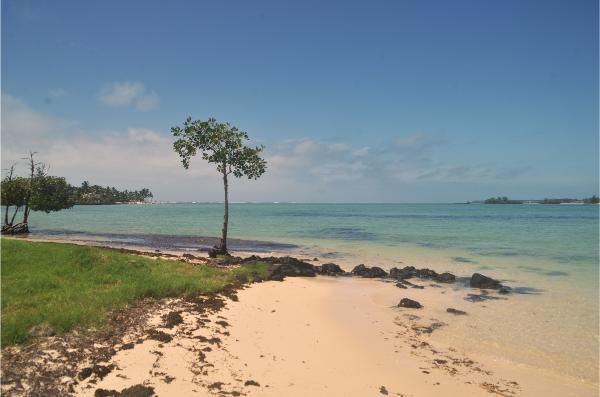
[98, 81, 159, 112]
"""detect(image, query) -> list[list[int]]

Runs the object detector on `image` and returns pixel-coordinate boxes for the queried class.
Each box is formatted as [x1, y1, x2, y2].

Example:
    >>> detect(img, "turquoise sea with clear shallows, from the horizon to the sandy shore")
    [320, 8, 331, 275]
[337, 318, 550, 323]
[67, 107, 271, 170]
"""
[10, 203, 600, 383]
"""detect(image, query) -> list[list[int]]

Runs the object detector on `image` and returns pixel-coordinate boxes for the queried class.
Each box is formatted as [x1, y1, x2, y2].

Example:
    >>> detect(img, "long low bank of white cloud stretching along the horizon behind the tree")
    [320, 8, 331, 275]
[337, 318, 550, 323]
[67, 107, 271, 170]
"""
[2, 95, 529, 201]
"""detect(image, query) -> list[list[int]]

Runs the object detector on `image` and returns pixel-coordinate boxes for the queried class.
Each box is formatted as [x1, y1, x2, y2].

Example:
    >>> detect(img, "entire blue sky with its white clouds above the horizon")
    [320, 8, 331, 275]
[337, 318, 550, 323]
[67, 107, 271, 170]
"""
[1, 0, 599, 202]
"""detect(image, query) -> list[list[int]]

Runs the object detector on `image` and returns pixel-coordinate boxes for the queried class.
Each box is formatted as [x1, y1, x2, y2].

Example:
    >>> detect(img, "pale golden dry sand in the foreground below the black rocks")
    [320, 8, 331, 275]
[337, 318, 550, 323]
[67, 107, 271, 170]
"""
[76, 276, 597, 396]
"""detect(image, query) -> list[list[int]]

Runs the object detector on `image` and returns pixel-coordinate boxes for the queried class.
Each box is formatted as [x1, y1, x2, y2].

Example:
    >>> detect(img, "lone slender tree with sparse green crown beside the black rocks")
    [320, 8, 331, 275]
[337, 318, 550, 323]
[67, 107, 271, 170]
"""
[171, 117, 267, 256]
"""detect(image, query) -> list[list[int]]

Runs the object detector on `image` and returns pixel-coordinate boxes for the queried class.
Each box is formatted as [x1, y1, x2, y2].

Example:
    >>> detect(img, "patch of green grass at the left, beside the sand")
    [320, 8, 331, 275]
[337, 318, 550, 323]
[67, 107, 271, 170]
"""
[1, 239, 267, 346]
